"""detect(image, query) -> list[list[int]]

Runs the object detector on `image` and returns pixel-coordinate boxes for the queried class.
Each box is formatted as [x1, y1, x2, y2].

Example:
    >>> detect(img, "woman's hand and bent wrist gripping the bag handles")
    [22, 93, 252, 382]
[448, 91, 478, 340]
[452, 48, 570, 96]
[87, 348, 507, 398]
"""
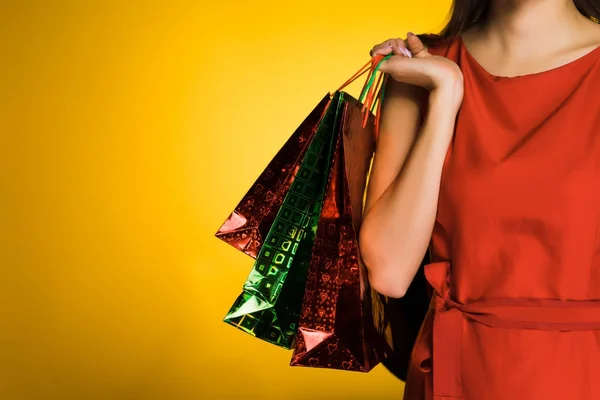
[370, 32, 463, 106]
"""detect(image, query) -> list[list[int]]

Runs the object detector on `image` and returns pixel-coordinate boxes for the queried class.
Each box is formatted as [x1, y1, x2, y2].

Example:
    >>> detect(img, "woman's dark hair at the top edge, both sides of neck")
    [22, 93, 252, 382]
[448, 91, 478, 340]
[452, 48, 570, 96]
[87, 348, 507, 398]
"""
[418, 0, 600, 47]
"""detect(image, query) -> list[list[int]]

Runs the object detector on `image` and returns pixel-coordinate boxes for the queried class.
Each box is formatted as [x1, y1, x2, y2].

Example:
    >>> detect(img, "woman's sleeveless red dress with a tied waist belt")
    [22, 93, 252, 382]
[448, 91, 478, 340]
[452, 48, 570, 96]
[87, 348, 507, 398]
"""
[404, 37, 600, 400]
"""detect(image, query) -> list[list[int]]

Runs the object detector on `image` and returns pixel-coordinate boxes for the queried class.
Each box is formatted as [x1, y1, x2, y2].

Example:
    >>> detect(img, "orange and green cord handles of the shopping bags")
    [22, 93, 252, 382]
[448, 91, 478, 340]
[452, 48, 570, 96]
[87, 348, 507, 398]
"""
[337, 54, 393, 136]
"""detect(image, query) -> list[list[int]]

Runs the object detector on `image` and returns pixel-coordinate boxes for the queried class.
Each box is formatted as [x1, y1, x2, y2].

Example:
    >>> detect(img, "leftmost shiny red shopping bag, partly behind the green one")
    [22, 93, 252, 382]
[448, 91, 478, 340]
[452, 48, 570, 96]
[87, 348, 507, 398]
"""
[215, 95, 331, 258]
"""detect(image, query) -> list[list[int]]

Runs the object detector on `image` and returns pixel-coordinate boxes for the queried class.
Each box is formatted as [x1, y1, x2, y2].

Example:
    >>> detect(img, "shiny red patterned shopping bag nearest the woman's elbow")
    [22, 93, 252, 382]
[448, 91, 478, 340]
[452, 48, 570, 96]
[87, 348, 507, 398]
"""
[291, 93, 392, 372]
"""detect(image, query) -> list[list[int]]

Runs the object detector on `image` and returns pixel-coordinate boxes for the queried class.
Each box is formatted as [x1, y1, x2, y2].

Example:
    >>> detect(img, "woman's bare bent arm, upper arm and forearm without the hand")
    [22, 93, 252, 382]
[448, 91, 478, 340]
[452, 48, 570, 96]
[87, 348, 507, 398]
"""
[359, 85, 462, 297]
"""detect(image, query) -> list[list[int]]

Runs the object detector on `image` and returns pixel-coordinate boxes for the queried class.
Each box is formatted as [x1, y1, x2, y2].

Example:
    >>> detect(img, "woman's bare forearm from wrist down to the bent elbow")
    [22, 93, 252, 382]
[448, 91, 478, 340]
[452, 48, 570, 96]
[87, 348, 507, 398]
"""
[359, 91, 457, 297]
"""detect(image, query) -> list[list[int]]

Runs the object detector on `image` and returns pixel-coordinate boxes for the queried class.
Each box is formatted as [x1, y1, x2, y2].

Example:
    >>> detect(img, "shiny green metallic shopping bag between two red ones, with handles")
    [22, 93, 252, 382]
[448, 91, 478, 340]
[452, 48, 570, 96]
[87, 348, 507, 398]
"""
[224, 54, 394, 348]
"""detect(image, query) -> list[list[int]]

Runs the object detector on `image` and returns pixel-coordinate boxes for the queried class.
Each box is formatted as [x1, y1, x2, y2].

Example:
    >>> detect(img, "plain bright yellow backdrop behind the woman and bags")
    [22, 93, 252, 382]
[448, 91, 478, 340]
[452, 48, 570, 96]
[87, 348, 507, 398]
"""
[0, 0, 449, 400]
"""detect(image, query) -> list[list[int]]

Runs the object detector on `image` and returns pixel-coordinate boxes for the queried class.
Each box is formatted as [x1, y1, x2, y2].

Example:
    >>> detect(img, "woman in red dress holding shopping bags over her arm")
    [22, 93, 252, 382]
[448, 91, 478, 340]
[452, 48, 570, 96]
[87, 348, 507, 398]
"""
[360, 0, 600, 400]
